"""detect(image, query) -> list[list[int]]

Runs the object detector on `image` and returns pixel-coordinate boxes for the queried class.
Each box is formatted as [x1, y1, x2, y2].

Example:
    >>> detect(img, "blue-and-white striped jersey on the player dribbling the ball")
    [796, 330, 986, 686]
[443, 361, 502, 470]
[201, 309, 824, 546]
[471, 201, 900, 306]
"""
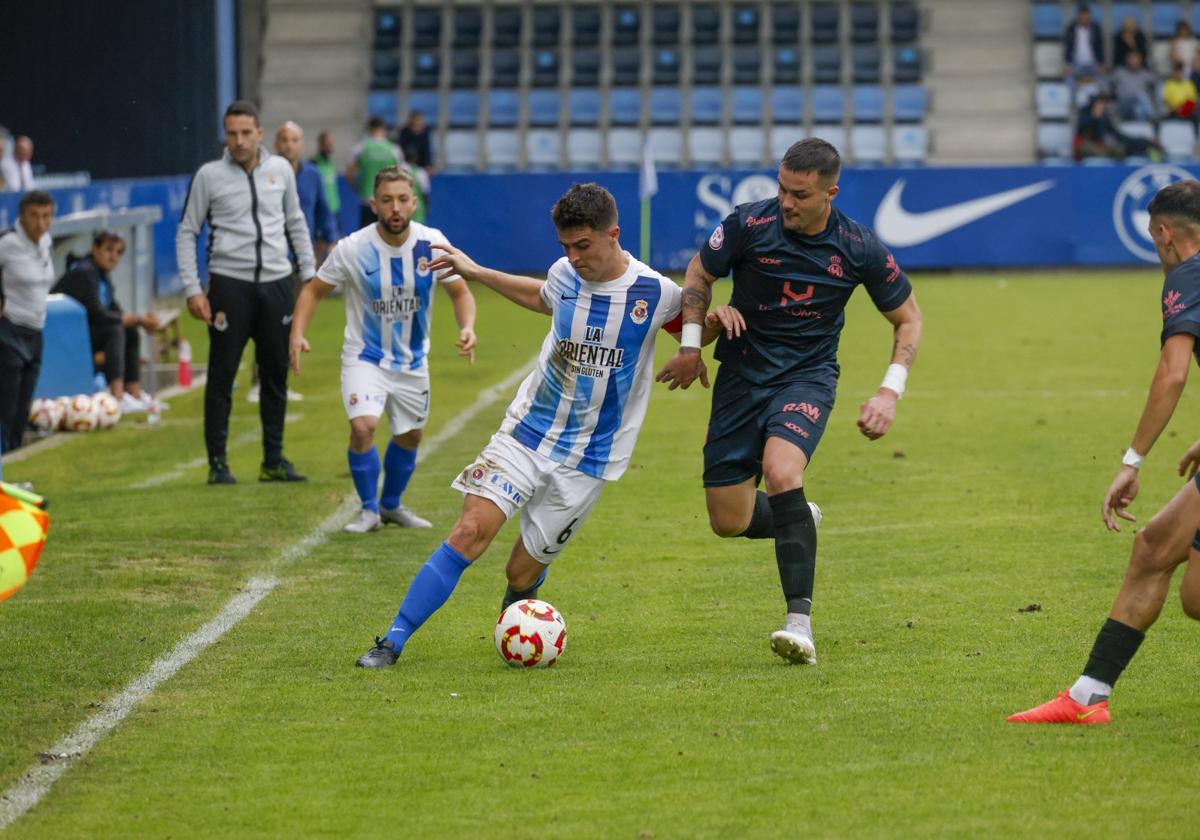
[500, 253, 683, 481]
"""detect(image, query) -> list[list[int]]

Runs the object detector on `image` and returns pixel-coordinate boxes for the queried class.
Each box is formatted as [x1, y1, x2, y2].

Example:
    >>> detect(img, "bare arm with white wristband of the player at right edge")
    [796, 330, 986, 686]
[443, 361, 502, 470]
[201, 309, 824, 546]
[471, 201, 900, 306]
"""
[1100, 332, 1196, 530]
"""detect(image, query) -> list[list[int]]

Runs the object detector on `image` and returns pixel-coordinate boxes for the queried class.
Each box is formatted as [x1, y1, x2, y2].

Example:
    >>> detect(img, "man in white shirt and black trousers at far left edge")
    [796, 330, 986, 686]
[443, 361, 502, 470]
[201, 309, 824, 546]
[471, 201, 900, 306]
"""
[0, 190, 54, 451]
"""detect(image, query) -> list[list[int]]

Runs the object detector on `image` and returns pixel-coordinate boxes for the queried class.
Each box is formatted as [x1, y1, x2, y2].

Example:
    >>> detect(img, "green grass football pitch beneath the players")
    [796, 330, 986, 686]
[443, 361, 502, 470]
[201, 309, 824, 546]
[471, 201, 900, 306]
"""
[0, 269, 1200, 838]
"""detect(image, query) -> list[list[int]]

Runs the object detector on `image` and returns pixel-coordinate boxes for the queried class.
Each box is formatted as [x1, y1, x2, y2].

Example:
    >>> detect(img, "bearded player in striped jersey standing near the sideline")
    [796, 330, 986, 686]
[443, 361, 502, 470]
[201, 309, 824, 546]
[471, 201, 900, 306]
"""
[288, 167, 475, 533]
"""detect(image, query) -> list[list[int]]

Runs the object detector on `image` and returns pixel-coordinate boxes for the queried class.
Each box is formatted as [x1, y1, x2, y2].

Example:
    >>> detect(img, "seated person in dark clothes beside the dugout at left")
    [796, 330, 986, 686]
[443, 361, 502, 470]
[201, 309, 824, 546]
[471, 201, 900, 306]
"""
[50, 230, 168, 414]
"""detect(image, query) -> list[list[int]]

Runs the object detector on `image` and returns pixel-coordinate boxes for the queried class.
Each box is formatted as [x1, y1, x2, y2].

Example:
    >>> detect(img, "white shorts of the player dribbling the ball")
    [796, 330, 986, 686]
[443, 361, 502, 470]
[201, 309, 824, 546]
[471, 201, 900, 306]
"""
[450, 432, 605, 565]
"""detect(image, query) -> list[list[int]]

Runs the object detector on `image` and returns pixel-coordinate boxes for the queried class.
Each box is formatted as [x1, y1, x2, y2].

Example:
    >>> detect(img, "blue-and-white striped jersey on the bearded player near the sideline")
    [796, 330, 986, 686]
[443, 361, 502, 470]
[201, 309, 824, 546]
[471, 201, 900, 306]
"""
[317, 222, 454, 371]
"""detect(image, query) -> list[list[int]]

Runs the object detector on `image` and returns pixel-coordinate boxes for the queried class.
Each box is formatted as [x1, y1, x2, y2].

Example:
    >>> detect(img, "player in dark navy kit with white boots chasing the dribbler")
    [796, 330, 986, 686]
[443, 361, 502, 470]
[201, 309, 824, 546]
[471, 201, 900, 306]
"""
[658, 138, 922, 664]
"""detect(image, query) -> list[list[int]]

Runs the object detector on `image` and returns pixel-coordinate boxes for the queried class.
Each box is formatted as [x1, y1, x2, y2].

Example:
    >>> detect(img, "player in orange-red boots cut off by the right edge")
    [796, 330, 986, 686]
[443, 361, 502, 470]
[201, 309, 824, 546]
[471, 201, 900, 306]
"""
[1008, 181, 1200, 724]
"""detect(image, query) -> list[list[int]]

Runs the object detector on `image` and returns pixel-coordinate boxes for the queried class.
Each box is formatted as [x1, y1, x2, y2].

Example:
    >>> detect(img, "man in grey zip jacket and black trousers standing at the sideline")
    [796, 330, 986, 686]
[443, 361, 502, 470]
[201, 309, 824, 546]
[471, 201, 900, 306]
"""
[175, 102, 316, 484]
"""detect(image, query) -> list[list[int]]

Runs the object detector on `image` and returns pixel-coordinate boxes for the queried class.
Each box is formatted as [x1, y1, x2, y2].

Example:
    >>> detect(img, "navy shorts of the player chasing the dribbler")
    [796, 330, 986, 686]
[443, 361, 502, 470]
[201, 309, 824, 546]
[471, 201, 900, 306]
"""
[704, 367, 838, 487]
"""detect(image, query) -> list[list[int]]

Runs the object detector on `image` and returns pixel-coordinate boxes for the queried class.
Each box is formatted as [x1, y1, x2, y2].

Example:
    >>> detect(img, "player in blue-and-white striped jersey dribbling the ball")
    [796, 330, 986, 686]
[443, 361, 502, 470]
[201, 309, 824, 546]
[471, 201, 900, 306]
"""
[358, 184, 716, 668]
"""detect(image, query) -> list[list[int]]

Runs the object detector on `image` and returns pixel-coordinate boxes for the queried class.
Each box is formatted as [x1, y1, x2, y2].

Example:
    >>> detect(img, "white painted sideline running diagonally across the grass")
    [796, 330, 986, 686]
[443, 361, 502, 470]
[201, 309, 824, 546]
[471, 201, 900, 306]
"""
[0, 356, 536, 832]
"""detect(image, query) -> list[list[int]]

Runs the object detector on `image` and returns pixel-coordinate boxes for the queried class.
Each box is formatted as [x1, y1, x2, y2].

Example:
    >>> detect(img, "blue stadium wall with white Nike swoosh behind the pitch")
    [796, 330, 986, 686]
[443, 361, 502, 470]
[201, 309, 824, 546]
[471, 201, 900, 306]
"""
[0, 163, 1200, 294]
